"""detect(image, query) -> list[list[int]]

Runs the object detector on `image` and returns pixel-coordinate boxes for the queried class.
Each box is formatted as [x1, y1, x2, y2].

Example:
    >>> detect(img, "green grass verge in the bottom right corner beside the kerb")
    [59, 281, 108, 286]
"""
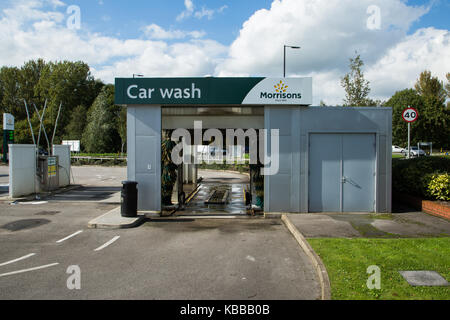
[308, 238, 450, 300]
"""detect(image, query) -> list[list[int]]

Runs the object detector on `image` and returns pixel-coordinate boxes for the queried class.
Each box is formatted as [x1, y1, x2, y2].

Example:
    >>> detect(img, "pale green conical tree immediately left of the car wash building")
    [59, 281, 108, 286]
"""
[81, 85, 120, 153]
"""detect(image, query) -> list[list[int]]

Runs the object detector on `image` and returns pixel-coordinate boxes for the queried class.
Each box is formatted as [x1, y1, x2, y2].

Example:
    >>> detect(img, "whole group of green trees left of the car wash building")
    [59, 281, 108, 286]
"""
[0, 59, 126, 153]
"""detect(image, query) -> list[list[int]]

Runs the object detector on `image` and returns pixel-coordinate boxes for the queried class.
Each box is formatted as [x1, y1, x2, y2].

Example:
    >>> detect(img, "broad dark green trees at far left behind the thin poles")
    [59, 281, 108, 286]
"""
[0, 59, 104, 147]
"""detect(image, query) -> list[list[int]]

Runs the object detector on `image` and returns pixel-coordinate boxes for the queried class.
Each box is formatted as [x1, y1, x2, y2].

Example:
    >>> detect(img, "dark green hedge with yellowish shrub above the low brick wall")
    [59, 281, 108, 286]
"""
[392, 157, 450, 201]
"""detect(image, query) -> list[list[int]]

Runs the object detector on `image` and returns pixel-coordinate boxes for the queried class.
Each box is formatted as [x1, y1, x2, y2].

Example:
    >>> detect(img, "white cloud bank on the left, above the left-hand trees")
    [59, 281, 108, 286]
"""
[0, 0, 226, 82]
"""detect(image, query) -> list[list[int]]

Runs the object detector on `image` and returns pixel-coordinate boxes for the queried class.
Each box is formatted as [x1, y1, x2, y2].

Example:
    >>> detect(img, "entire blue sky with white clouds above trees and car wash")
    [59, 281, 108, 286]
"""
[0, 0, 450, 105]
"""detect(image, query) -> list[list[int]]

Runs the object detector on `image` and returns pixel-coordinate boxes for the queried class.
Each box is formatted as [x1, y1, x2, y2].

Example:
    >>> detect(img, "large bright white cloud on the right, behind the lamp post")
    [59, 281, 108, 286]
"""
[216, 0, 449, 104]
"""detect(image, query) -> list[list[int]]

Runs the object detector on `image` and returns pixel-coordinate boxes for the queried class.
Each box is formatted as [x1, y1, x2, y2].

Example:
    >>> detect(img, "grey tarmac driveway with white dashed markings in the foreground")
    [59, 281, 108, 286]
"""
[0, 216, 320, 300]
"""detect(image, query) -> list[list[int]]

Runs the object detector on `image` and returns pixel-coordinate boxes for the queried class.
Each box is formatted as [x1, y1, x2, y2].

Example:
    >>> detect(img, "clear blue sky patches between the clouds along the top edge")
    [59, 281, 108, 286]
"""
[9, 0, 442, 45]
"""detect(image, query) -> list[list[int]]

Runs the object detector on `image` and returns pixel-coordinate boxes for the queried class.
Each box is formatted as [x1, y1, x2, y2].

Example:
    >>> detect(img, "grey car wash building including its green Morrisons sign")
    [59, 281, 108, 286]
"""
[115, 77, 392, 213]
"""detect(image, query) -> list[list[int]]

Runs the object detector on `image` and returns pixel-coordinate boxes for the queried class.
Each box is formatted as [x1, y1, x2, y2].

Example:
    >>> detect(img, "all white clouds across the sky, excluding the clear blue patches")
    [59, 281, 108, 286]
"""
[0, 0, 450, 105]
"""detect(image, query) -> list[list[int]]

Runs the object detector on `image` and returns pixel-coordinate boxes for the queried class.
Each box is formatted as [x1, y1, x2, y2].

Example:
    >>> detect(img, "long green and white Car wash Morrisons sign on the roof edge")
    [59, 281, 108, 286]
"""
[115, 77, 312, 105]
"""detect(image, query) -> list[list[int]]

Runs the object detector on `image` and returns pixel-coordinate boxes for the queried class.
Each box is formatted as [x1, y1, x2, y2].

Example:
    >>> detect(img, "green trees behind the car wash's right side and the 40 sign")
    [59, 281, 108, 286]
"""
[340, 54, 450, 150]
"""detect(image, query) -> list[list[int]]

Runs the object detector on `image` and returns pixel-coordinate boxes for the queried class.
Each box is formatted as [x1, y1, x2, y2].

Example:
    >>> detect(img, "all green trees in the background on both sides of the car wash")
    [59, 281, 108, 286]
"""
[0, 57, 450, 153]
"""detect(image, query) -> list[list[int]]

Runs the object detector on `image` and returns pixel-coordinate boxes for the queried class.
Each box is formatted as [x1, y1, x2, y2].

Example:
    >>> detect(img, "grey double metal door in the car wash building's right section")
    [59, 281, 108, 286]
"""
[308, 134, 376, 212]
